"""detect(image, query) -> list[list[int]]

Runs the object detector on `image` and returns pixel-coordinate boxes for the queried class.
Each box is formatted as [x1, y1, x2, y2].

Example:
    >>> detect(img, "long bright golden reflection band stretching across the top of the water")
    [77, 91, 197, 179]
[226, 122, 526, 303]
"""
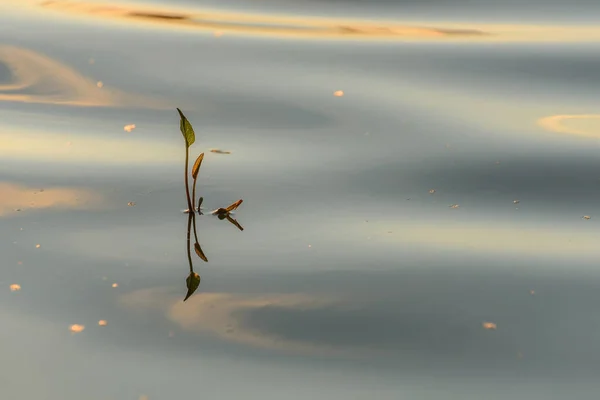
[0, 0, 600, 42]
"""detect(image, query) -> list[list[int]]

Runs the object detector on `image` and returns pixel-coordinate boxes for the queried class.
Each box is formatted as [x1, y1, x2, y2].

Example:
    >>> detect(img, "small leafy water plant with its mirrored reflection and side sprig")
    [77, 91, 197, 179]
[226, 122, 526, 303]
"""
[177, 108, 244, 301]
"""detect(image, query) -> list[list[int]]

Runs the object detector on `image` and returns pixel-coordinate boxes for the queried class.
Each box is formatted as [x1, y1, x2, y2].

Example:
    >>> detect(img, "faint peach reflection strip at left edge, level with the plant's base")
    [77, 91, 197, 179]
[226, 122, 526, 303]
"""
[0, 182, 103, 217]
